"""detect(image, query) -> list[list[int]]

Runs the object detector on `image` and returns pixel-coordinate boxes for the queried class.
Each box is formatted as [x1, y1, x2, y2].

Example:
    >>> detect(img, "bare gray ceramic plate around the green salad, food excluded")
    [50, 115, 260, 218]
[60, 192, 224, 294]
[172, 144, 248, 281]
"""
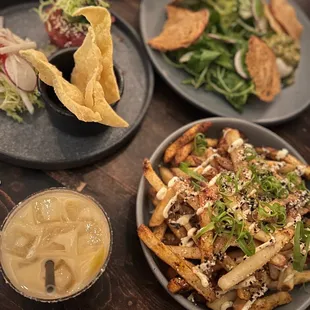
[140, 0, 310, 125]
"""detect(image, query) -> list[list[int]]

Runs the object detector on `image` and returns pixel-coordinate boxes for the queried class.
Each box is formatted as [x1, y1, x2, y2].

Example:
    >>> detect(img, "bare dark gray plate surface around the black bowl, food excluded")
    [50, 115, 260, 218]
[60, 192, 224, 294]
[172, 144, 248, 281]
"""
[0, 0, 154, 169]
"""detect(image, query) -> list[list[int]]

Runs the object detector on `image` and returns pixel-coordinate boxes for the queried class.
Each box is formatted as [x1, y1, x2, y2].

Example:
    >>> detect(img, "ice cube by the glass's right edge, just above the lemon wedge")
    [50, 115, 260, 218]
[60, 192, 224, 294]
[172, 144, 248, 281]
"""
[78, 222, 103, 254]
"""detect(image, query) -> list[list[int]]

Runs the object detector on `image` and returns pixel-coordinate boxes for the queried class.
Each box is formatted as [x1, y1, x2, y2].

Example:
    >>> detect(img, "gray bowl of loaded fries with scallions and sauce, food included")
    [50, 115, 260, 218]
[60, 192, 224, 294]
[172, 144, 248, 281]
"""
[137, 118, 310, 310]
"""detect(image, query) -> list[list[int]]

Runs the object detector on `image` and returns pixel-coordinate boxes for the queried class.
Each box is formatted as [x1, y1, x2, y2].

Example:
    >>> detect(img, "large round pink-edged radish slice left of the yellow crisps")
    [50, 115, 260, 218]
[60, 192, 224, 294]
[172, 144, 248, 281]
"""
[4, 54, 37, 92]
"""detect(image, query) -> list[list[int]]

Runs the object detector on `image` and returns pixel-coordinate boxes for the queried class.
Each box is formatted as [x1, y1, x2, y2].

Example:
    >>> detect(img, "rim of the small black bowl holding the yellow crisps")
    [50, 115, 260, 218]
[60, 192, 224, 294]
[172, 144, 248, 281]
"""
[37, 47, 125, 119]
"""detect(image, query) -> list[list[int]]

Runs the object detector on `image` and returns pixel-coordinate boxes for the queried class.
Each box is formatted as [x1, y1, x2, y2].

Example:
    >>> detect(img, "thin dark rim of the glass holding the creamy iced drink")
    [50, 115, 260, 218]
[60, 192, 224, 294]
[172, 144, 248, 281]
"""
[0, 187, 113, 303]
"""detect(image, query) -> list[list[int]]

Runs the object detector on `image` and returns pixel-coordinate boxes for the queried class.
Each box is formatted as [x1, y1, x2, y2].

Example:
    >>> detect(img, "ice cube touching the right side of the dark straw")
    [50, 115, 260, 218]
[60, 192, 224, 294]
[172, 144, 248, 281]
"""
[55, 259, 75, 294]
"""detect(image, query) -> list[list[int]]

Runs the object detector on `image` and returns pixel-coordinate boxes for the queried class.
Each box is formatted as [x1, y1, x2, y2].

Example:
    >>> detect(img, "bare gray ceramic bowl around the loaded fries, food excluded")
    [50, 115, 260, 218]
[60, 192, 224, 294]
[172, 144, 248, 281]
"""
[136, 117, 310, 310]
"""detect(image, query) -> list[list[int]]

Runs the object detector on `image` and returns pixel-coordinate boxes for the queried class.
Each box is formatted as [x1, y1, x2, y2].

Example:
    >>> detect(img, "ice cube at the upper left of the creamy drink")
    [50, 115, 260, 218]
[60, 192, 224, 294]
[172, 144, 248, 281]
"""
[32, 197, 64, 224]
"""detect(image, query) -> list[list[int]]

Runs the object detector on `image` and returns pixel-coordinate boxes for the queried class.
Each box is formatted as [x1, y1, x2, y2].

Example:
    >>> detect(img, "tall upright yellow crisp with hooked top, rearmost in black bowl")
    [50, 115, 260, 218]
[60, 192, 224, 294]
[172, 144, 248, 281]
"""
[74, 6, 120, 104]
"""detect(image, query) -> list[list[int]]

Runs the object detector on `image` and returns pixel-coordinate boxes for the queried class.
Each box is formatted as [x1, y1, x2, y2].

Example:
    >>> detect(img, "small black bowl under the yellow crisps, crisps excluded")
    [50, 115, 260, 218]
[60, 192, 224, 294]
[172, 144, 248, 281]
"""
[38, 47, 124, 136]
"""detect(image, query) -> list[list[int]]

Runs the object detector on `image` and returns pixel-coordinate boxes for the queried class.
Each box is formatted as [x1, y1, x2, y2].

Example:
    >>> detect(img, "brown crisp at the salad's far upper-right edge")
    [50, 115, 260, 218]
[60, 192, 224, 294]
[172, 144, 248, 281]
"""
[270, 0, 303, 41]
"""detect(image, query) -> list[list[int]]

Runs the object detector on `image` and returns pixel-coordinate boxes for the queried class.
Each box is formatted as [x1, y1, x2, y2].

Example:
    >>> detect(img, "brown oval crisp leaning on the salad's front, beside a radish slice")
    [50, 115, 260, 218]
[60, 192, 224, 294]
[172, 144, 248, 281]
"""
[246, 36, 281, 102]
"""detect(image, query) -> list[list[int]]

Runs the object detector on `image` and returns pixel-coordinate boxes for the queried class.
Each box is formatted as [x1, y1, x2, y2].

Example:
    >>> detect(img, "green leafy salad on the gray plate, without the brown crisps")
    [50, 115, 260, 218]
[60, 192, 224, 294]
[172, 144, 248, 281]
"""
[162, 0, 300, 112]
